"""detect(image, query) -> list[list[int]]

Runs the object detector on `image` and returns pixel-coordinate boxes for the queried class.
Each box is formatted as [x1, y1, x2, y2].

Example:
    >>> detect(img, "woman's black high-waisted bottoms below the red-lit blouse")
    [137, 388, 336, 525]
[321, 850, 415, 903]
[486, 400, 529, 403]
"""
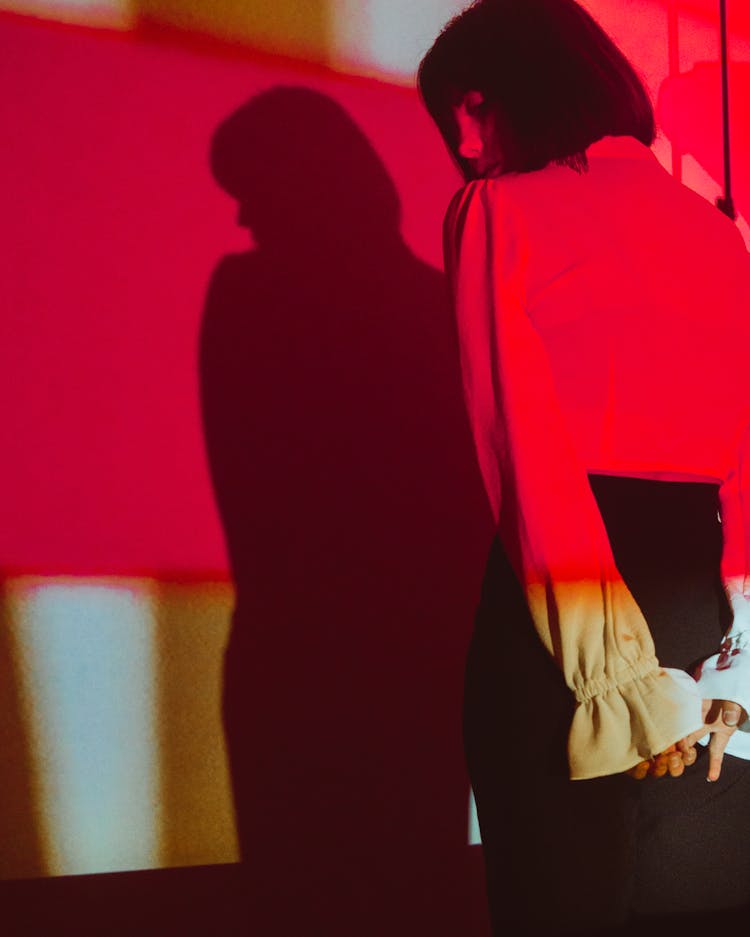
[464, 476, 750, 935]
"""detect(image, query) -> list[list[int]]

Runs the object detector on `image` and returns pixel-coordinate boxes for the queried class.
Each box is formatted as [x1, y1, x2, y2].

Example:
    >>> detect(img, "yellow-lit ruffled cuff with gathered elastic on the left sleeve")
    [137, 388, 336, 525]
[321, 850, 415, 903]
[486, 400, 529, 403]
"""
[568, 658, 704, 780]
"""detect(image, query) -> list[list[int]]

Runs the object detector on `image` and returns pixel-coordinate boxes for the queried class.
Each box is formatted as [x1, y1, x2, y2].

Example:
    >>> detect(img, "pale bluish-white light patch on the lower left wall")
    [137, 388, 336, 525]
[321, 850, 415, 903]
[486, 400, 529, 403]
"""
[14, 582, 159, 875]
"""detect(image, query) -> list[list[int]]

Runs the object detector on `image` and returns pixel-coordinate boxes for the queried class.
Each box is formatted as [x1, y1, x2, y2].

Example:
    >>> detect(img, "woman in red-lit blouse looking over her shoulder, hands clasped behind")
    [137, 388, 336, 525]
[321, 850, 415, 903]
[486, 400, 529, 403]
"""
[419, 0, 750, 934]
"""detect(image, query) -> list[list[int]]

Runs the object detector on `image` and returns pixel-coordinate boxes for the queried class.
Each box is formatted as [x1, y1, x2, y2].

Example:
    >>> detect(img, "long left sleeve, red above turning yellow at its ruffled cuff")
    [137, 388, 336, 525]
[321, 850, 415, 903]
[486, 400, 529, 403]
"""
[444, 178, 702, 779]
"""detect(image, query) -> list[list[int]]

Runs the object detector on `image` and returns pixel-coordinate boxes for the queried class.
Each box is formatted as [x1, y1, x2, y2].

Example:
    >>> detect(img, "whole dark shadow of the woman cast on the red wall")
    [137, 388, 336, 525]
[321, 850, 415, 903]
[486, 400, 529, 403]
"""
[200, 87, 490, 937]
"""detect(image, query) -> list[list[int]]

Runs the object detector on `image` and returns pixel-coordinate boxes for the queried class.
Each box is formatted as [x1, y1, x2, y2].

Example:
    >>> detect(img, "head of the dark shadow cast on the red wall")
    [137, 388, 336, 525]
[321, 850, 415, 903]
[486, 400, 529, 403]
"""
[210, 87, 400, 249]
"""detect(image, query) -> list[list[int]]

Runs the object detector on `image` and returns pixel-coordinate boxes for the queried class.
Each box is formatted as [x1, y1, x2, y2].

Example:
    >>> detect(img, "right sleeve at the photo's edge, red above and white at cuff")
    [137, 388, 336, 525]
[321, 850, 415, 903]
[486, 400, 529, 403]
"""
[695, 427, 750, 758]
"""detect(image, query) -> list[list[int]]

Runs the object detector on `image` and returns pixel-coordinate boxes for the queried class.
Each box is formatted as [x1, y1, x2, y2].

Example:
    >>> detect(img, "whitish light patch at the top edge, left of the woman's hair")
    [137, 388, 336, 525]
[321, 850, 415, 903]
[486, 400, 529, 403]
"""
[329, 0, 467, 83]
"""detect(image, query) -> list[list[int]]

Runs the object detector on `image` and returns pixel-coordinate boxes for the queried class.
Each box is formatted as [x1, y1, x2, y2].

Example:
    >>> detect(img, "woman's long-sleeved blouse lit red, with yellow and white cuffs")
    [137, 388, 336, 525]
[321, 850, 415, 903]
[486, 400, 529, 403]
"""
[444, 137, 750, 779]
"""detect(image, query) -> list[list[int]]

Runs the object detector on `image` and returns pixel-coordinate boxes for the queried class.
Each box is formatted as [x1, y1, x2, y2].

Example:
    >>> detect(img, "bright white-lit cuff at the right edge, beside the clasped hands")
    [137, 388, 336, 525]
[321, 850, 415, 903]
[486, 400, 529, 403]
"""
[695, 595, 750, 759]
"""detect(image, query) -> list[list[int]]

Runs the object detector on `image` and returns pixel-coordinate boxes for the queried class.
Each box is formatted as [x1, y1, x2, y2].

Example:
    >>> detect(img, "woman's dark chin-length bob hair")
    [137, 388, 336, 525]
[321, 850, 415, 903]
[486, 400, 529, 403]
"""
[417, 0, 656, 180]
